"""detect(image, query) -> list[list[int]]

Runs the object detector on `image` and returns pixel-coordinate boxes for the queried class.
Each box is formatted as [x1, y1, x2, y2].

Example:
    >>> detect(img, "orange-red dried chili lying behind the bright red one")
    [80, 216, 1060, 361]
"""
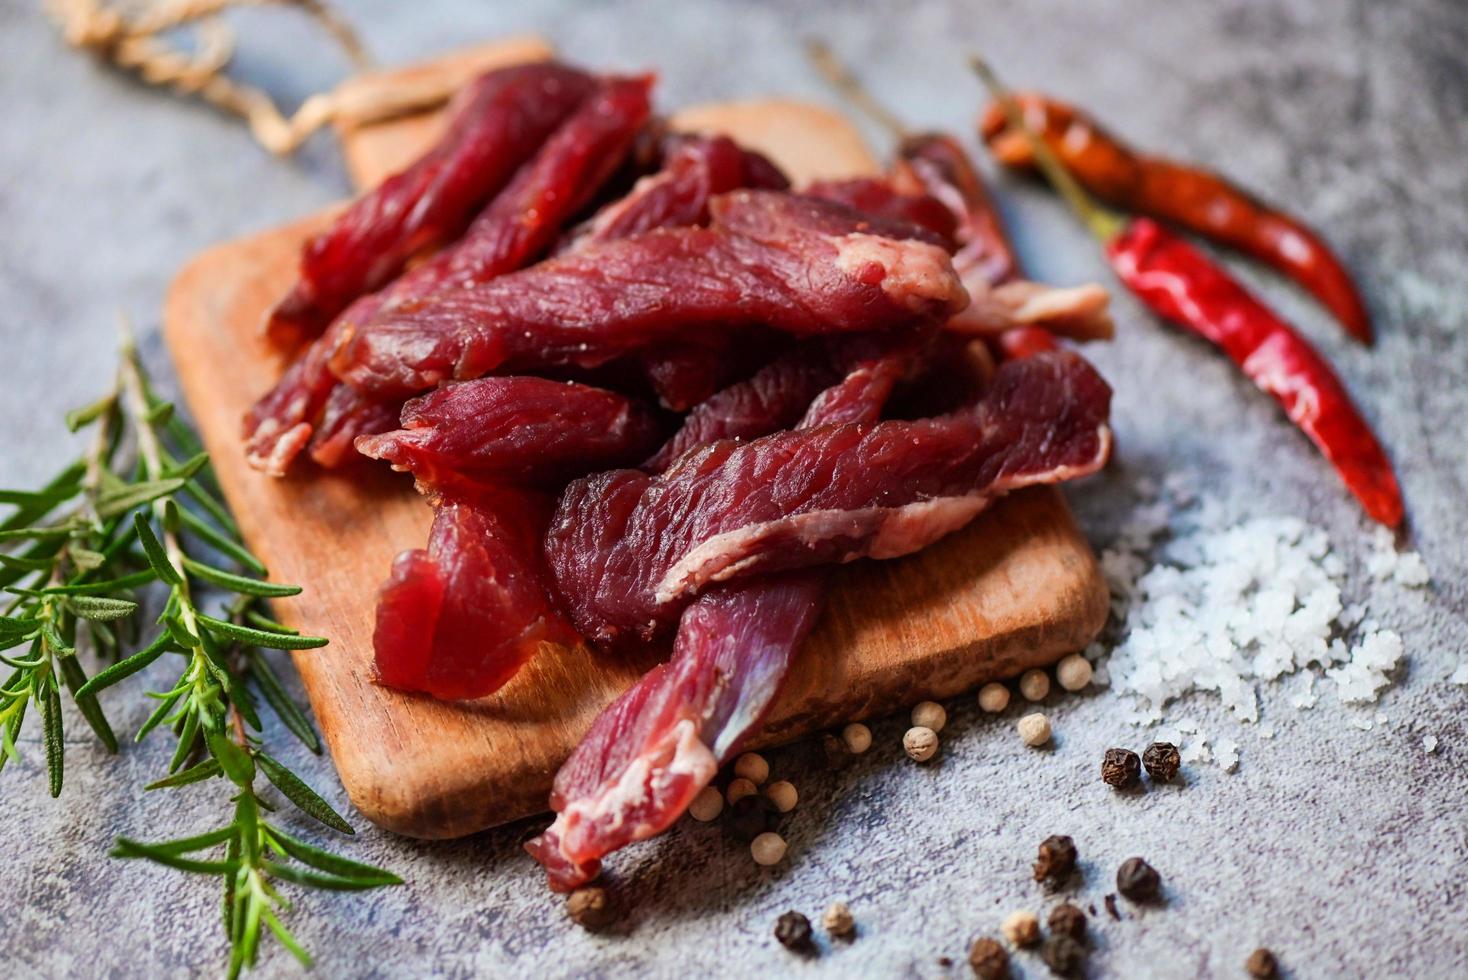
[979, 92, 1371, 345]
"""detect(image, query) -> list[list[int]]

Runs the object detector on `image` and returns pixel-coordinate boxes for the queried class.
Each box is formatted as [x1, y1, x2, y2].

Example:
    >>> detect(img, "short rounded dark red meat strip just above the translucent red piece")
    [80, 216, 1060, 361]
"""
[357, 377, 661, 490]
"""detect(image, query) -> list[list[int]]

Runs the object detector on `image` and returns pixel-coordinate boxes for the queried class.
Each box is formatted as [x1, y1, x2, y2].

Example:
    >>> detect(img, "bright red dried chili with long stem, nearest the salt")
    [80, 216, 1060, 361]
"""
[973, 59, 1403, 527]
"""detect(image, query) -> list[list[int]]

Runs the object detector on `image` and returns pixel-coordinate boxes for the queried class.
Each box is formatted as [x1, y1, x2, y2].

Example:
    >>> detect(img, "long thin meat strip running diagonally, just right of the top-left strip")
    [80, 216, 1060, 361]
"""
[245, 78, 652, 475]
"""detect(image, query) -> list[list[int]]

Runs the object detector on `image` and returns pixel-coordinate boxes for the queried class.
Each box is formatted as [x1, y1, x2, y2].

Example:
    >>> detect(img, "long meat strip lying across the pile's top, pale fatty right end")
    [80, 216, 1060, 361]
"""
[332, 191, 967, 398]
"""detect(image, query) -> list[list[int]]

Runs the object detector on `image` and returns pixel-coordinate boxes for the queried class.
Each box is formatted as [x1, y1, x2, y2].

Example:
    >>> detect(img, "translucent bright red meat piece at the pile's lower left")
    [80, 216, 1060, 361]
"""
[373, 489, 575, 698]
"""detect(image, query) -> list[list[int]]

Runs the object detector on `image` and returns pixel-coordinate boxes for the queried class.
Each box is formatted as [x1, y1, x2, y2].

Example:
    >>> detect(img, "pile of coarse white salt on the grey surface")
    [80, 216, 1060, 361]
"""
[1086, 474, 1432, 772]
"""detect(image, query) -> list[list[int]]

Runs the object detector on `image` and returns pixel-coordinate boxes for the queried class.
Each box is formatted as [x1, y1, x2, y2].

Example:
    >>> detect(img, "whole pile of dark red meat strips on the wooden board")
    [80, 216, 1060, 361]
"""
[245, 63, 1110, 889]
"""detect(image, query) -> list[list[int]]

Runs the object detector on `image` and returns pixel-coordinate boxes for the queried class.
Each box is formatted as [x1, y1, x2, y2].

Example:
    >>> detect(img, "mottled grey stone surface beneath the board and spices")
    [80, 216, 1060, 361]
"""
[0, 0, 1468, 977]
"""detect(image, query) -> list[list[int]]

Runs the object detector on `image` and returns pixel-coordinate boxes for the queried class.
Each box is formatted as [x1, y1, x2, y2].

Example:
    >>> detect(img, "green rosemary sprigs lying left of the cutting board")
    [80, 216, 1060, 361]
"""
[0, 337, 401, 977]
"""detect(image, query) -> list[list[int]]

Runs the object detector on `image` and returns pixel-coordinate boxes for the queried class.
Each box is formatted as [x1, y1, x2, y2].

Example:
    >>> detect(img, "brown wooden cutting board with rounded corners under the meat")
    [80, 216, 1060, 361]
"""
[164, 38, 1107, 838]
